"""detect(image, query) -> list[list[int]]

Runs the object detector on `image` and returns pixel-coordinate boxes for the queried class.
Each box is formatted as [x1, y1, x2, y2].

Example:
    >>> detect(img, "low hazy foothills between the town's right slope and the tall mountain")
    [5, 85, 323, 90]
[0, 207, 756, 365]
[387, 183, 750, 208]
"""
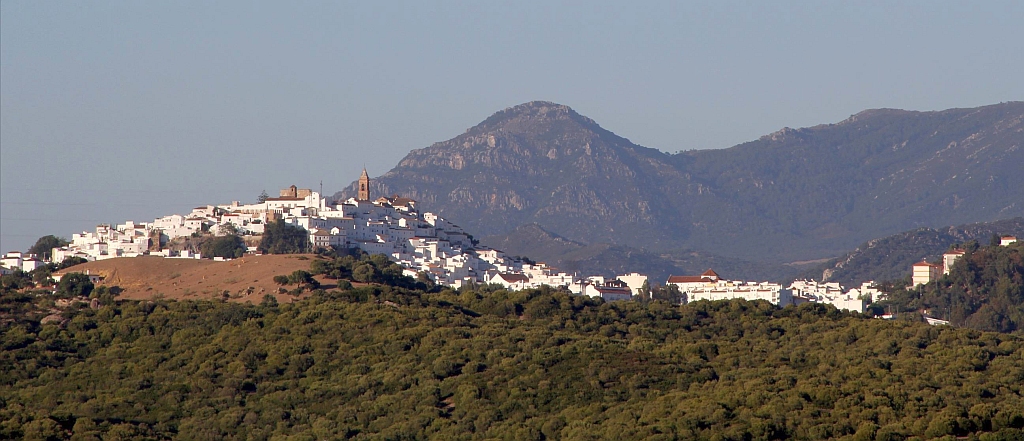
[480, 223, 798, 284]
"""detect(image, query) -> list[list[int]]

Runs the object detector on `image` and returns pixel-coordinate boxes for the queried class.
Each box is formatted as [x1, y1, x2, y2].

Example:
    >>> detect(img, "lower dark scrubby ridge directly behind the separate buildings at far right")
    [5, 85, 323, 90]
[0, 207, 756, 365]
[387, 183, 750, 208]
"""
[803, 217, 1024, 285]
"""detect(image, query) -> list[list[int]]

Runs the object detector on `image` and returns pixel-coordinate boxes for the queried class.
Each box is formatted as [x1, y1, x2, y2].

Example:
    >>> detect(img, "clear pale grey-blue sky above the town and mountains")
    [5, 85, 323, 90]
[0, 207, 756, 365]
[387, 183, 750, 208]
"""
[0, 0, 1024, 252]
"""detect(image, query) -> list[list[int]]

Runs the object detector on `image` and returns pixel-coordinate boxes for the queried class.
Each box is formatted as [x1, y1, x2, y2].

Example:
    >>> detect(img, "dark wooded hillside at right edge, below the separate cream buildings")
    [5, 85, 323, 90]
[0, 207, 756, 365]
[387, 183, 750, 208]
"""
[881, 240, 1024, 333]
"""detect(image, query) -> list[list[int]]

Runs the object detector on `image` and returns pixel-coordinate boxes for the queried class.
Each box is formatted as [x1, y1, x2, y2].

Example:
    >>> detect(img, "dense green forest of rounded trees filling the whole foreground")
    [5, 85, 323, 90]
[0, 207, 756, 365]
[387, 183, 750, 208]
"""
[0, 252, 1024, 440]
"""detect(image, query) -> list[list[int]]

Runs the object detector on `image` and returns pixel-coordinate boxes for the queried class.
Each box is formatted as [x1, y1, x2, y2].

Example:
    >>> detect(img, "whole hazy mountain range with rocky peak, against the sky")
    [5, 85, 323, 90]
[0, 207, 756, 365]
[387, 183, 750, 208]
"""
[336, 101, 1024, 262]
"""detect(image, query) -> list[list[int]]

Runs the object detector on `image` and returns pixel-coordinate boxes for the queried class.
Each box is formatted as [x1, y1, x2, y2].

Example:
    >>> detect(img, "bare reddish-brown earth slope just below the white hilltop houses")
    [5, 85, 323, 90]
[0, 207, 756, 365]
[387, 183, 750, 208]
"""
[52, 255, 336, 303]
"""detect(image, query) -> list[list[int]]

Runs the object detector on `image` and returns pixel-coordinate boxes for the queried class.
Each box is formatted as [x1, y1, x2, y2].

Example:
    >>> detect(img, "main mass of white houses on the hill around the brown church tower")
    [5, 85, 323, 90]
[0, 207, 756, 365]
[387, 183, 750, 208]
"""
[19, 170, 643, 301]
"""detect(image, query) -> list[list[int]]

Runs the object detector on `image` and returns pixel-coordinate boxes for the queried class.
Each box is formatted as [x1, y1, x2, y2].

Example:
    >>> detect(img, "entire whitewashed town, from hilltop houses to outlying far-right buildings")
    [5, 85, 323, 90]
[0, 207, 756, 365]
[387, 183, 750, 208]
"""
[6, 170, 1016, 313]
